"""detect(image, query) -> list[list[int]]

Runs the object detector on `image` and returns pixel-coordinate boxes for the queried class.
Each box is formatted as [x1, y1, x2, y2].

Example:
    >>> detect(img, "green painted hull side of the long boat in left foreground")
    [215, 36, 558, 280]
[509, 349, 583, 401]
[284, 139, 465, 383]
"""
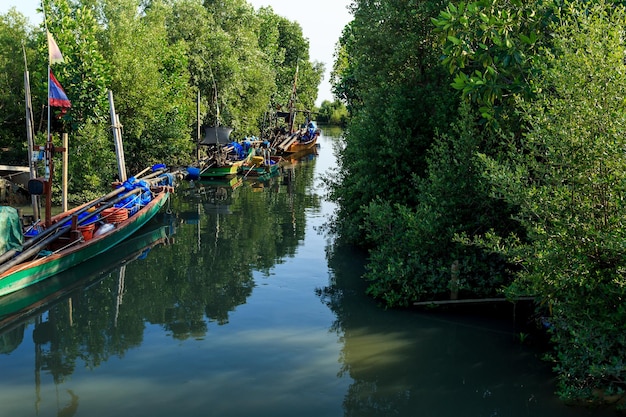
[0, 190, 169, 296]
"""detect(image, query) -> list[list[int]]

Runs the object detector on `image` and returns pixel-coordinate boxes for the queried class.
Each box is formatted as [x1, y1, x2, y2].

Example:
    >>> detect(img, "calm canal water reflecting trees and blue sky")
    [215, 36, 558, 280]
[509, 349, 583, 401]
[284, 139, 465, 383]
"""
[0, 129, 611, 417]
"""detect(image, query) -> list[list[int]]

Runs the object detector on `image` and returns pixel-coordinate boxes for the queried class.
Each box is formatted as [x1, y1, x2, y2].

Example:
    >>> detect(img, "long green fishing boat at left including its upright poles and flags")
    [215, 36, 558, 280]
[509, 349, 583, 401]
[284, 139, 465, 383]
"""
[0, 24, 176, 296]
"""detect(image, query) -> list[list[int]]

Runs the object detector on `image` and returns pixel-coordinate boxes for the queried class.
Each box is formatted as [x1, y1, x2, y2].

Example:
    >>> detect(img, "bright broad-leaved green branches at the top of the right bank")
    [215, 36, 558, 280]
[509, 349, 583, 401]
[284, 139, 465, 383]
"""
[432, 0, 551, 122]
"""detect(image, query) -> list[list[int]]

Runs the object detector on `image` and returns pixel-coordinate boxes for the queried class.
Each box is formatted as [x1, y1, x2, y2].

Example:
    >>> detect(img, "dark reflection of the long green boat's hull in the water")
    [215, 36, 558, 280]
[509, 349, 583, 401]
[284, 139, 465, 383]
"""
[0, 223, 169, 333]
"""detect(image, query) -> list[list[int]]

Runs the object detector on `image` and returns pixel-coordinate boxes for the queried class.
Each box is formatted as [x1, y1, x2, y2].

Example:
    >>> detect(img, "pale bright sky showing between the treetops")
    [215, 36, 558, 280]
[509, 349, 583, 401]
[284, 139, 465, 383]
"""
[0, 0, 352, 106]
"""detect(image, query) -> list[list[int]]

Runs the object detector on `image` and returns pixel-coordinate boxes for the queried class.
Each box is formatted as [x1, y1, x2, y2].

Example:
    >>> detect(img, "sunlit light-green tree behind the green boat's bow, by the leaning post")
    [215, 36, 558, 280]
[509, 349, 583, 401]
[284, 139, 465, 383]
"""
[97, 0, 195, 174]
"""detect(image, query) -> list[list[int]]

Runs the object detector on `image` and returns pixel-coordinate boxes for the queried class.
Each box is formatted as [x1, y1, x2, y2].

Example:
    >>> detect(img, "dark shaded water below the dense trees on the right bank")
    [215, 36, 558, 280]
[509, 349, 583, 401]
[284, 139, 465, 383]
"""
[318, 240, 613, 417]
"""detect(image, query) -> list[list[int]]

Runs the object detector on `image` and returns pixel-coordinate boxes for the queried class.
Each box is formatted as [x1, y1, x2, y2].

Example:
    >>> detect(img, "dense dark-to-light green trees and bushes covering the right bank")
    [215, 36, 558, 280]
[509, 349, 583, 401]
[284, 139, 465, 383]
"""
[327, 0, 626, 400]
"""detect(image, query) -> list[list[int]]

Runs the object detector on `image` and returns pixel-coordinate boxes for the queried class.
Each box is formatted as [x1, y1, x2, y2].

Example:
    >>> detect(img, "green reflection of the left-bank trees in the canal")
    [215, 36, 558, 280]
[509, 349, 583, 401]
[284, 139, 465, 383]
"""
[0, 154, 320, 388]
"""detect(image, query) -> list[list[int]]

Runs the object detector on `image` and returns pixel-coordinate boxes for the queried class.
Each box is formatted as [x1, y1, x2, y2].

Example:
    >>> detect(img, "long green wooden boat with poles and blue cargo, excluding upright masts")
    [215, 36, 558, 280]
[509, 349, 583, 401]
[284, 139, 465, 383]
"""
[0, 169, 173, 295]
